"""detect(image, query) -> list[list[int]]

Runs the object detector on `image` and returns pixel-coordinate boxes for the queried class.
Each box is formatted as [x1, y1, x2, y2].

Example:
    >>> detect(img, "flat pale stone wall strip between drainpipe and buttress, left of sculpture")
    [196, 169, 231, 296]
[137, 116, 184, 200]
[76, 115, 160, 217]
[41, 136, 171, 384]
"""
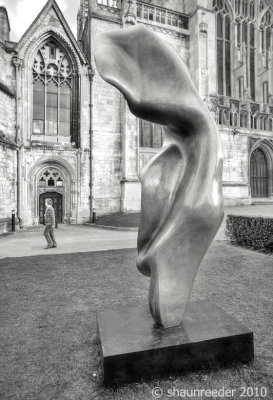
[91, 18, 122, 215]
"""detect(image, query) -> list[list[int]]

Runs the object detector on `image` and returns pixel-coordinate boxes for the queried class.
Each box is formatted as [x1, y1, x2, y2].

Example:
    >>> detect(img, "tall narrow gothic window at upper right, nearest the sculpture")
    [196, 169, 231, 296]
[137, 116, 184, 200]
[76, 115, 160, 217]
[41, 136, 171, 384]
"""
[213, 0, 231, 96]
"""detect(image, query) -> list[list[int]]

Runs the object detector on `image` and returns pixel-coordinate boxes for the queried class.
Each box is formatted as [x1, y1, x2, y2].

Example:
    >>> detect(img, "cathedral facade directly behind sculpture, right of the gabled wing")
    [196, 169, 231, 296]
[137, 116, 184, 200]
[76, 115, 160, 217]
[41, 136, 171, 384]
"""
[78, 0, 273, 217]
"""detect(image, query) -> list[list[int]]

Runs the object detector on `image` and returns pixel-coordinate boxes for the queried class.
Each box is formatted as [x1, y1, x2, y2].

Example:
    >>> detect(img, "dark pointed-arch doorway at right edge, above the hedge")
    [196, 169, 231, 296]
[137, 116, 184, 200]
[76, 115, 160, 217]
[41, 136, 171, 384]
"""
[250, 148, 269, 197]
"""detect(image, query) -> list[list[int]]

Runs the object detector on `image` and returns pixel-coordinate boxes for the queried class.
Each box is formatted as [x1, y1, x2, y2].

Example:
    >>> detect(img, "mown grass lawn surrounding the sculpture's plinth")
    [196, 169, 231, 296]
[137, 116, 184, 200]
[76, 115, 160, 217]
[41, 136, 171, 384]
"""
[0, 242, 273, 400]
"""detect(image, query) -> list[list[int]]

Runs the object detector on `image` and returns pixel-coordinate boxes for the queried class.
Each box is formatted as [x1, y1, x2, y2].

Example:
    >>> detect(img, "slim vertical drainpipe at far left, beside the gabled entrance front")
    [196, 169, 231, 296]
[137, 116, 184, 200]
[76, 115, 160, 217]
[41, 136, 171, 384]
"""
[13, 57, 24, 228]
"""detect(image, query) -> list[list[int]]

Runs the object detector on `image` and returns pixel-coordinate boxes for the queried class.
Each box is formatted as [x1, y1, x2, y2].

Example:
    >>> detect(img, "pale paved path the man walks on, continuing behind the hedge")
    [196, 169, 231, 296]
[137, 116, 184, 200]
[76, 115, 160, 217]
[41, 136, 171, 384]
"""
[0, 205, 273, 259]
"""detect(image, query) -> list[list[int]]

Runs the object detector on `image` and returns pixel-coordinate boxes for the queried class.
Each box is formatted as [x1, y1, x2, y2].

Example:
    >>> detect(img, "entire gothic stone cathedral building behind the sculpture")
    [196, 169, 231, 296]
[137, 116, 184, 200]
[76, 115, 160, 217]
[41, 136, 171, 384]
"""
[0, 0, 273, 233]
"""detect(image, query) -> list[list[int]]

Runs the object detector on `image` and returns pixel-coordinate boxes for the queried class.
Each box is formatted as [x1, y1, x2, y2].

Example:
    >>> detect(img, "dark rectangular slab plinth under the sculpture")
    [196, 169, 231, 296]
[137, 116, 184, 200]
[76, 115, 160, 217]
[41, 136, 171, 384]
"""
[97, 301, 254, 385]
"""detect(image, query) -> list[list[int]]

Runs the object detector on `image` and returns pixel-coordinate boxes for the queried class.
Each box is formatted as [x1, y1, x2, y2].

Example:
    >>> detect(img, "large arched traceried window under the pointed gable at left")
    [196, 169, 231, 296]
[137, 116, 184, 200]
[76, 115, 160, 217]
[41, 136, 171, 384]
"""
[33, 41, 73, 142]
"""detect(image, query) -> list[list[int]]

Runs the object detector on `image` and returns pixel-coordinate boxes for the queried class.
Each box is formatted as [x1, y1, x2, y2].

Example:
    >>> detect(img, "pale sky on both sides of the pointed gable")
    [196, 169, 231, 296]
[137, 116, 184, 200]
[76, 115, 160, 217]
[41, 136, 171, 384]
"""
[0, 0, 80, 42]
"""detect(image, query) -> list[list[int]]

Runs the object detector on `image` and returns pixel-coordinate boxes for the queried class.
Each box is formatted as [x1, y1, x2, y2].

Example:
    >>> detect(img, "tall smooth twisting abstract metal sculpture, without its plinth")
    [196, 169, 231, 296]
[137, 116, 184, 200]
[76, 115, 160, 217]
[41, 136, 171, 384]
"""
[95, 25, 224, 328]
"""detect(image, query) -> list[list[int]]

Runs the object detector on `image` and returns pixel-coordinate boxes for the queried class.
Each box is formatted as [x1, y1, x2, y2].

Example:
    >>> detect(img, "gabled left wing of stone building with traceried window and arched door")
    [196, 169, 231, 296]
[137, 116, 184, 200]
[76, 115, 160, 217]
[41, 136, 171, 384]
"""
[0, 0, 90, 231]
